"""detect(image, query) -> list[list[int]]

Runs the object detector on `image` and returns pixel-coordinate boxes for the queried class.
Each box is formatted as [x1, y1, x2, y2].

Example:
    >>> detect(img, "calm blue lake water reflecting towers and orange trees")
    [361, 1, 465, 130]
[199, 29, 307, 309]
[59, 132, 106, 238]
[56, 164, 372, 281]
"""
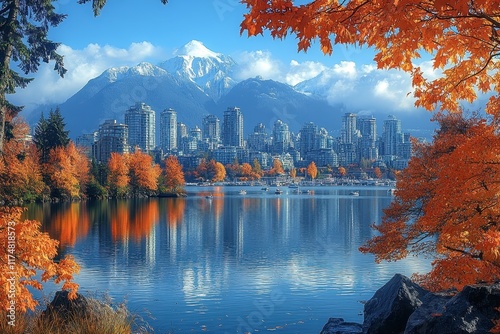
[27, 187, 429, 333]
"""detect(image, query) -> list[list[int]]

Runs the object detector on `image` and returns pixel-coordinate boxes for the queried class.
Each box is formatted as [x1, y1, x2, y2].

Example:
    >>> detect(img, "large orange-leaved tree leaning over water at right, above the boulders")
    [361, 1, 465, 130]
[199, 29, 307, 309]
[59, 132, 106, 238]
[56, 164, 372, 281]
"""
[361, 114, 500, 290]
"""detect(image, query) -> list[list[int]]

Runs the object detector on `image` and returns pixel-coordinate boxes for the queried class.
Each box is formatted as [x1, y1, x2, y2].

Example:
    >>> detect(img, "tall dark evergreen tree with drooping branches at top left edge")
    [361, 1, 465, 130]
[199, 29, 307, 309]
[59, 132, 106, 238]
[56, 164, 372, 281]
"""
[0, 0, 167, 154]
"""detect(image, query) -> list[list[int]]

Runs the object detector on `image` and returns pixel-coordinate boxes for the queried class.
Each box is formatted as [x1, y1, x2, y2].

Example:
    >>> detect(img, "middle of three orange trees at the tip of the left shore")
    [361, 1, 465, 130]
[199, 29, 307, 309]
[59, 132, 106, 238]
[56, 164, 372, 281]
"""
[128, 150, 161, 196]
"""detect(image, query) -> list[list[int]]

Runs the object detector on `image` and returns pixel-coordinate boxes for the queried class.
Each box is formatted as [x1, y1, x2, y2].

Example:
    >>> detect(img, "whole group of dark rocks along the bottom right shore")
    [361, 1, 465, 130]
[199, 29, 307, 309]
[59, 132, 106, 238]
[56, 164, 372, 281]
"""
[321, 274, 500, 334]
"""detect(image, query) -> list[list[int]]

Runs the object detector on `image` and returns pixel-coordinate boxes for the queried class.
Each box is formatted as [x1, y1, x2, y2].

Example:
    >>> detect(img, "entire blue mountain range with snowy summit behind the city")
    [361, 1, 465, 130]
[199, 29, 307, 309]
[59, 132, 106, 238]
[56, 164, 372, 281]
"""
[29, 41, 436, 137]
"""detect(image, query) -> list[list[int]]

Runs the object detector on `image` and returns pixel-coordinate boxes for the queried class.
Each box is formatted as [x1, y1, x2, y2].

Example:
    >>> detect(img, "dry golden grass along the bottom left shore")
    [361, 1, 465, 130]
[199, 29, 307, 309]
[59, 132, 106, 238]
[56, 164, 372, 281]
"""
[0, 298, 152, 334]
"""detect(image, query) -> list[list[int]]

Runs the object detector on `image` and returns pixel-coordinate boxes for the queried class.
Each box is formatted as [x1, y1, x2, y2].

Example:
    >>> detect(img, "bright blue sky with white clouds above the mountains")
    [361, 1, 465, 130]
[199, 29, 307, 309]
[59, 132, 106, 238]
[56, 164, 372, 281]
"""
[10, 0, 434, 130]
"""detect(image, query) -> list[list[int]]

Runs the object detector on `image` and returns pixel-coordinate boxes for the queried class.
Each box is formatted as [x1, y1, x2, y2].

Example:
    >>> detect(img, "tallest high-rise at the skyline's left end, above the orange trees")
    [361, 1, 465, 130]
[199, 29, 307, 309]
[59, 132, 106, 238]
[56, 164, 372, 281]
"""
[125, 103, 156, 152]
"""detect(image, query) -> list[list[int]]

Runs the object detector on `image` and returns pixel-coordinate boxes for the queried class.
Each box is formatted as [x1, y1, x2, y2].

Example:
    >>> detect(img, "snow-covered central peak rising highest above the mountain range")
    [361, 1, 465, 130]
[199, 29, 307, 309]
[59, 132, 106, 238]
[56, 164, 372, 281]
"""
[159, 41, 237, 101]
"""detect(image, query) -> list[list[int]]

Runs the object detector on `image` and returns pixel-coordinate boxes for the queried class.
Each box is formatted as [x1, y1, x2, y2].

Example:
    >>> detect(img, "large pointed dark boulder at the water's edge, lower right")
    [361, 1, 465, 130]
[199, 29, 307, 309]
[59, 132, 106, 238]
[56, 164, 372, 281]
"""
[363, 274, 429, 334]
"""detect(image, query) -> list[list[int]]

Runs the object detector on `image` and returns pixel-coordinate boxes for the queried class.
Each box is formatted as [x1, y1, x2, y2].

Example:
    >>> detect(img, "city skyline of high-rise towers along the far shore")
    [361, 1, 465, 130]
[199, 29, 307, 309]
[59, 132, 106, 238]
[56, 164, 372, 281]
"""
[86, 103, 411, 169]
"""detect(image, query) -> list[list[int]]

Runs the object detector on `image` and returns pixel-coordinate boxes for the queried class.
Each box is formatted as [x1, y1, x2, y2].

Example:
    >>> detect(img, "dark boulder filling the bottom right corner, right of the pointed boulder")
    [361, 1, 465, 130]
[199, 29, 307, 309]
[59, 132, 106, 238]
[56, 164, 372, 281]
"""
[405, 283, 500, 334]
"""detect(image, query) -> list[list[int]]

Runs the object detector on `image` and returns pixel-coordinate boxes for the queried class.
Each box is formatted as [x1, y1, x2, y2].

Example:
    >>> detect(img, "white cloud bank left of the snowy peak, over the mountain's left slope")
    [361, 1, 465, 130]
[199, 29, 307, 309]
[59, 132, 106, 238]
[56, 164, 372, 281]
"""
[9, 42, 165, 111]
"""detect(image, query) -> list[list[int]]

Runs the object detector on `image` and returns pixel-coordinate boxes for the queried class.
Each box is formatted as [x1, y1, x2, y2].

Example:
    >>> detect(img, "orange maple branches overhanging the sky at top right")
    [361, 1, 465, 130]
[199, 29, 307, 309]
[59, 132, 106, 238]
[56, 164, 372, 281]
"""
[241, 0, 500, 115]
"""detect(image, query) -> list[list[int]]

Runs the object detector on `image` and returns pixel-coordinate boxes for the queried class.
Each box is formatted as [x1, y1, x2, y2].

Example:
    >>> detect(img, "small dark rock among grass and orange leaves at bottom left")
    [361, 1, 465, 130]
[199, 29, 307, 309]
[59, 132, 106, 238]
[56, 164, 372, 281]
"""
[43, 291, 90, 319]
